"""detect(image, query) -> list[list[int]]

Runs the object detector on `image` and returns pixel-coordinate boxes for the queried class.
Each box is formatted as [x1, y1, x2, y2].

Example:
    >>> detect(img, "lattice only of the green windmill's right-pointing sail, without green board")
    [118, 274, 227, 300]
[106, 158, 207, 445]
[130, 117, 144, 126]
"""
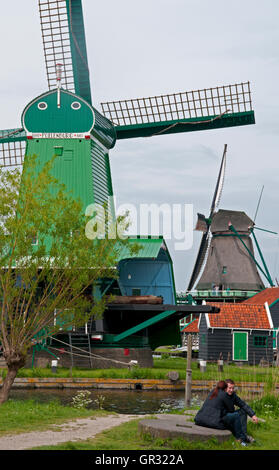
[101, 82, 252, 126]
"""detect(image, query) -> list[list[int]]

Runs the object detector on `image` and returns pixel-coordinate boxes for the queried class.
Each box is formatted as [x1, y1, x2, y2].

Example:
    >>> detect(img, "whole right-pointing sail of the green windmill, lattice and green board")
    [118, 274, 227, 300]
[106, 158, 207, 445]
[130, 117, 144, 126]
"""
[101, 82, 255, 139]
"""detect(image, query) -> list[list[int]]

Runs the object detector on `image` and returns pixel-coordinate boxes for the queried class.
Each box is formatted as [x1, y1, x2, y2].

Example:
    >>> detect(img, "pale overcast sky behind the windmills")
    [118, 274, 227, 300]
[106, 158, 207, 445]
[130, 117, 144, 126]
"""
[0, 0, 279, 290]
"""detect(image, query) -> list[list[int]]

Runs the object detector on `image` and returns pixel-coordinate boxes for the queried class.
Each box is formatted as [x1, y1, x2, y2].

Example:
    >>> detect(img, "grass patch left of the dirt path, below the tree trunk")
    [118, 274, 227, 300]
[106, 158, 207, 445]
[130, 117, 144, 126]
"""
[0, 400, 111, 436]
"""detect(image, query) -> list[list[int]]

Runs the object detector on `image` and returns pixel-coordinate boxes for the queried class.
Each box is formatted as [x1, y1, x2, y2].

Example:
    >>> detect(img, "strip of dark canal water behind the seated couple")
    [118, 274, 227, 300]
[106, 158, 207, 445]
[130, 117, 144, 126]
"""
[10, 389, 207, 415]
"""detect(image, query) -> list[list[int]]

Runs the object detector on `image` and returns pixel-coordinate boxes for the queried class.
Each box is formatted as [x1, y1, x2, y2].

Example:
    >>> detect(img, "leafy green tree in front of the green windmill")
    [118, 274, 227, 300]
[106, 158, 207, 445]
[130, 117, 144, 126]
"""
[0, 156, 131, 403]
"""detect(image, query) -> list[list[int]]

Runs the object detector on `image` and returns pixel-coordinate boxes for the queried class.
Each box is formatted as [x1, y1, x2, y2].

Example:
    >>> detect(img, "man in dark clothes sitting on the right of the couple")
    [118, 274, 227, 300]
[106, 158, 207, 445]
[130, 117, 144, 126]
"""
[222, 379, 258, 445]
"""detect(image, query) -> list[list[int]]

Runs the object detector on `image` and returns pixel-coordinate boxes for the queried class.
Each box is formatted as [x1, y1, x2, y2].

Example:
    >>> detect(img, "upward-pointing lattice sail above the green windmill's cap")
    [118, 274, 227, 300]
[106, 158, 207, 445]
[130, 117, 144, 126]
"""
[39, 0, 92, 104]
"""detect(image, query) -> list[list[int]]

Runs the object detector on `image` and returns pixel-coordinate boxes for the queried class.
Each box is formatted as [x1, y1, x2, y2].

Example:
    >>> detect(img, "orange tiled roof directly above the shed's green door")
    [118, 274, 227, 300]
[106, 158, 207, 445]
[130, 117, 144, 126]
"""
[207, 302, 272, 330]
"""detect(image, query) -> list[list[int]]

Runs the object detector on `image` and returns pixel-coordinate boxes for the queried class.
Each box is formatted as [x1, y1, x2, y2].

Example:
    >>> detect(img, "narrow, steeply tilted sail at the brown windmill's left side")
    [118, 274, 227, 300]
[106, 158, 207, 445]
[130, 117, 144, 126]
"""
[187, 144, 227, 291]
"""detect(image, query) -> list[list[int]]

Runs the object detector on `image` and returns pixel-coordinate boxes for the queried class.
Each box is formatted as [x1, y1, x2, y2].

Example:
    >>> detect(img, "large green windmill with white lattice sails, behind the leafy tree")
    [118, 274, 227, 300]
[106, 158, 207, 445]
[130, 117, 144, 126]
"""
[0, 0, 255, 368]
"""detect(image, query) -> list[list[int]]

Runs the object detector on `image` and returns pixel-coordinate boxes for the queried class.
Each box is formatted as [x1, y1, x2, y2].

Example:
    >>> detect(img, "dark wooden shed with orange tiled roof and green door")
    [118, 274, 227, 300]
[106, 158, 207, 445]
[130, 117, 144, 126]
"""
[198, 303, 273, 365]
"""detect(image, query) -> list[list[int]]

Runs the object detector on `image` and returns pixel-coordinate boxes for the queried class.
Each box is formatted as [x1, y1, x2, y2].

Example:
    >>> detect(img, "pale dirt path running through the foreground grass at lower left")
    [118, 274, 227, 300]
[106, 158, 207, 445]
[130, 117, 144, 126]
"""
[0, 414, 139, 450]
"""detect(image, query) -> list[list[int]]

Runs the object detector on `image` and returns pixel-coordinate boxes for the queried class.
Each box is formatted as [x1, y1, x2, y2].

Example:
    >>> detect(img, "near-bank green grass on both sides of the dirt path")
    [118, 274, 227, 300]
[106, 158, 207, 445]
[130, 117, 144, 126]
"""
[0, 395, 279, 450]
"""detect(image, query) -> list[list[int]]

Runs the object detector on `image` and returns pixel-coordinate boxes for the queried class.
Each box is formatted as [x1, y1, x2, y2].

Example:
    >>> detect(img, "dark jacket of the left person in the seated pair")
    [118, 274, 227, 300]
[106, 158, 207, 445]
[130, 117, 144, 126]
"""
[194, 390, 228, 429]
